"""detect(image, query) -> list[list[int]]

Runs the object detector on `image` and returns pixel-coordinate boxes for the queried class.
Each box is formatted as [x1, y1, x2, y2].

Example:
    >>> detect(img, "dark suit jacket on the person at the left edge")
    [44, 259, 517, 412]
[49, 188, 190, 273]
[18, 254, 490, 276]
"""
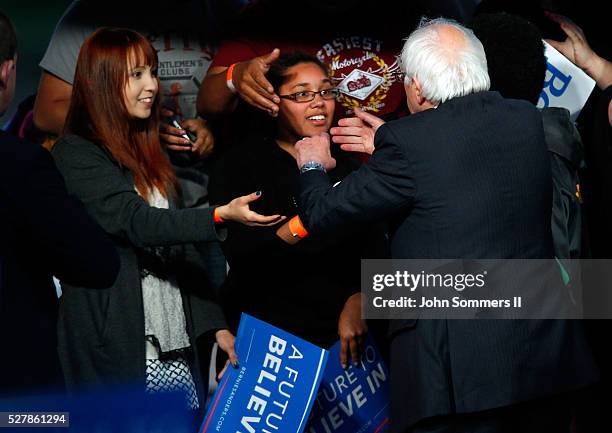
[0, 131, 119, 394]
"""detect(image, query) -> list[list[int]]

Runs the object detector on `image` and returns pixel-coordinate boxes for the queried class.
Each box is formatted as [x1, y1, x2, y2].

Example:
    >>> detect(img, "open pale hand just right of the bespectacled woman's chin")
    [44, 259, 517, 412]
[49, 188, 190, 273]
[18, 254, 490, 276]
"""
[330, 108, 385, 155]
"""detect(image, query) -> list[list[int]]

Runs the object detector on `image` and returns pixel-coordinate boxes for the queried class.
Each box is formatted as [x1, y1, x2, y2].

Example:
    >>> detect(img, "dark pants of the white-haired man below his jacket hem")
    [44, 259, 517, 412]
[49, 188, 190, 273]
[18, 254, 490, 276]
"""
[406, 395, 571, 433]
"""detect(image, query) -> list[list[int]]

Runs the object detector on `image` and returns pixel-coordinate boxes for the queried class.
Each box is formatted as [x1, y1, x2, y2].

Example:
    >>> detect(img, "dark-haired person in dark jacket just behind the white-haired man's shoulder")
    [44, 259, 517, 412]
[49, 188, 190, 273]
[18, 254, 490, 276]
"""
[472, 13, 584, 260]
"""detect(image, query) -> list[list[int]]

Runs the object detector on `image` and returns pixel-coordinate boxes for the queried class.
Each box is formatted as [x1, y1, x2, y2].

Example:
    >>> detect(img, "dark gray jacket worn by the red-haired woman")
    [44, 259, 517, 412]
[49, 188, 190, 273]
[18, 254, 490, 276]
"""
[52, 135, 226, 395]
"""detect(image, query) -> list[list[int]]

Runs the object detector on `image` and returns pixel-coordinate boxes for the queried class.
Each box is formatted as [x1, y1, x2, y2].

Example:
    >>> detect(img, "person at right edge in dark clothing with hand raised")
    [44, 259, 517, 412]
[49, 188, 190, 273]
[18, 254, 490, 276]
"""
[547, 14, 612, 433]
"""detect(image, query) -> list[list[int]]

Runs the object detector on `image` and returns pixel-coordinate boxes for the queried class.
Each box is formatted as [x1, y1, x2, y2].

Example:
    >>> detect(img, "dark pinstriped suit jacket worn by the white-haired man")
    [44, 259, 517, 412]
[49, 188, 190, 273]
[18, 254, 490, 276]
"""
[301, 92, 593, 432]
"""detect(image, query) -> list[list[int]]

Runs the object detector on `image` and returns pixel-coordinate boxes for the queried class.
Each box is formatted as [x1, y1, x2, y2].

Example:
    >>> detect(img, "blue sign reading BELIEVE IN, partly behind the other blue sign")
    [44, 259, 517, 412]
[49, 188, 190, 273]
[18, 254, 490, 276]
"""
[306, 337, 389, 433]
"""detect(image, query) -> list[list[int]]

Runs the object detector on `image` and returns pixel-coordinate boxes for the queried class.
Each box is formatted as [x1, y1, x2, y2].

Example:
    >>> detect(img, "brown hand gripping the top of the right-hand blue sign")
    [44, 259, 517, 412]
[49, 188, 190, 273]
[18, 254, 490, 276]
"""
[338, 293, 368, 369]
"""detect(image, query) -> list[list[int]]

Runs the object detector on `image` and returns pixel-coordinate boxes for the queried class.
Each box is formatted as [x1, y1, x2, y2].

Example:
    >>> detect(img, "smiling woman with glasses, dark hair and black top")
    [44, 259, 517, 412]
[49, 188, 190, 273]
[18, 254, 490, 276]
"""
[210, 52, 384, 362]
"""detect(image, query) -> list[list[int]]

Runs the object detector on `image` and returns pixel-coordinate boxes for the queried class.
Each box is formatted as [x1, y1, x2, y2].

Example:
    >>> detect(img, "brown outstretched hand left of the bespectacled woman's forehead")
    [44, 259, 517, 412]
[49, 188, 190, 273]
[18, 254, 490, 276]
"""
[232, 48, 280, 117]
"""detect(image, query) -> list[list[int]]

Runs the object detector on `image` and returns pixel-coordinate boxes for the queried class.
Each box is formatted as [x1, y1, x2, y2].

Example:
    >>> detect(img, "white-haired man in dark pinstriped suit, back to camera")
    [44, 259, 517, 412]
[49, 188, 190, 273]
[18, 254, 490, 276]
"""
[294, 19, 596, 433]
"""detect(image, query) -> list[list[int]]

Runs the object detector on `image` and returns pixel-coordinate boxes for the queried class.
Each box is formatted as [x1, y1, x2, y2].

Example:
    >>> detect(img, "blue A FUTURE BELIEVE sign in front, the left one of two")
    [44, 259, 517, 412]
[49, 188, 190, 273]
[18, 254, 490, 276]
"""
[200, 314, 328, 433]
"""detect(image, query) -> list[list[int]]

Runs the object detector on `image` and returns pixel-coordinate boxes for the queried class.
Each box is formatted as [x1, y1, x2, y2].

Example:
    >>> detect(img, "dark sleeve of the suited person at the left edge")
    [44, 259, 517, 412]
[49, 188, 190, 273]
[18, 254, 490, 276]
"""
[0, 138, 119, 288]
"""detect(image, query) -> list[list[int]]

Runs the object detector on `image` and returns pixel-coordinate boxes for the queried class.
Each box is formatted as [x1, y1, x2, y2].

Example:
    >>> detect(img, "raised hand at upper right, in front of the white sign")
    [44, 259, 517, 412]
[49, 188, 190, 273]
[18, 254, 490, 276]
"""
[545, 12, 612, 89]
